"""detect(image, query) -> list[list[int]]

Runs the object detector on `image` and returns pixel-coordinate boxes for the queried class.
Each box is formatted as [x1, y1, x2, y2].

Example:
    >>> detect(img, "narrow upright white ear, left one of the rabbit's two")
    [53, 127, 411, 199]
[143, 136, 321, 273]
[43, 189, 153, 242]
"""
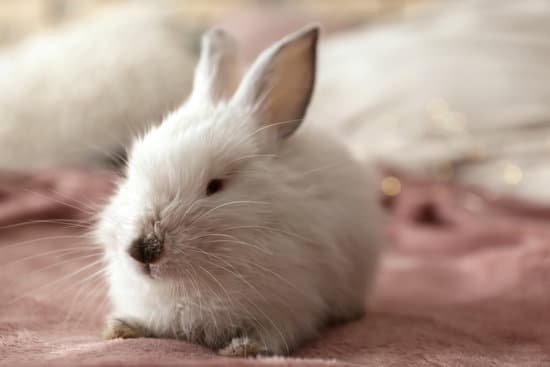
[191, 28, 241, 102]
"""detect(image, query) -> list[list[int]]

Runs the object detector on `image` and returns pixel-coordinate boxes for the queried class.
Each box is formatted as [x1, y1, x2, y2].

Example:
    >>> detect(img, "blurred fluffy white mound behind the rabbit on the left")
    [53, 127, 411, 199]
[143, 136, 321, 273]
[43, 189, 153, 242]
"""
[0, 5, 195, 170]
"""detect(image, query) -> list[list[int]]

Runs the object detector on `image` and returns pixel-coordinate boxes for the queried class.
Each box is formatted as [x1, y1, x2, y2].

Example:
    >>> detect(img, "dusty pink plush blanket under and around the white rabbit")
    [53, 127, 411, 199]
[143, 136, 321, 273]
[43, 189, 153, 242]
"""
[0, 171, 550, 366]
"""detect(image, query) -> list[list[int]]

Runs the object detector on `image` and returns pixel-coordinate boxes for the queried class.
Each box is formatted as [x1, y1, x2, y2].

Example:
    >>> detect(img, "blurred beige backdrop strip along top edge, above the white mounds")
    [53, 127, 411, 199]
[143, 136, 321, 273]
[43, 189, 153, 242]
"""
[0, 0, 437, 44]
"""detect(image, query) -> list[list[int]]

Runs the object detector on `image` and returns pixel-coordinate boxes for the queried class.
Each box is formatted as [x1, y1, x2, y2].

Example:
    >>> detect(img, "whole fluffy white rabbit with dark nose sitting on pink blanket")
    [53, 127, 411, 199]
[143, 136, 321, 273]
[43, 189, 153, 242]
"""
[97, 27, 381, 356]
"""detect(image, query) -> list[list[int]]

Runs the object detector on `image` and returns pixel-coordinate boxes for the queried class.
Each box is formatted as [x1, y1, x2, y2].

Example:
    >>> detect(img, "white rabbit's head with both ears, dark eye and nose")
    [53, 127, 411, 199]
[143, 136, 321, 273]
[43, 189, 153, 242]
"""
[97, 27, 319, 282]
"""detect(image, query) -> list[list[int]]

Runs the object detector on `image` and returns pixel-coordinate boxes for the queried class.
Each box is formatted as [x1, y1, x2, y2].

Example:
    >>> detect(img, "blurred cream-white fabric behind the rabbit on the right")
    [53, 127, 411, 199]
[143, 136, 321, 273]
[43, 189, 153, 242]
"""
[309, 0, 550, 202]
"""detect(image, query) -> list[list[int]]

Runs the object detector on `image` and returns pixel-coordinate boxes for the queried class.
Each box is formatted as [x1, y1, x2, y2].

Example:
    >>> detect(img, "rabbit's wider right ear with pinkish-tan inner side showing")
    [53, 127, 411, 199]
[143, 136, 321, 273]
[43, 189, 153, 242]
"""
[232, 26, 319, 138]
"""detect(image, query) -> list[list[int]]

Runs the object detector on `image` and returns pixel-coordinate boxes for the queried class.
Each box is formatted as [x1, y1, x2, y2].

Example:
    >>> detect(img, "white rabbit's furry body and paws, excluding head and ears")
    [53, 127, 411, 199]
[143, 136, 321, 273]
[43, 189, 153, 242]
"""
[103, 124, 380, 353]
